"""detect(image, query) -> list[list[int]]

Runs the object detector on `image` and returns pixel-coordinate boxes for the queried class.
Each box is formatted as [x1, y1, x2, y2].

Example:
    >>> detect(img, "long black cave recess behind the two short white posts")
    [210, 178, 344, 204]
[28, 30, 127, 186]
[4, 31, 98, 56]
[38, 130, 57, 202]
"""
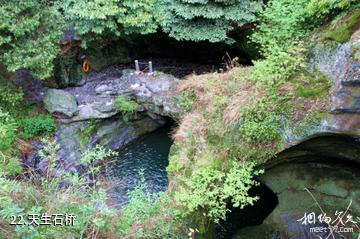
[86, 27, 259, 78]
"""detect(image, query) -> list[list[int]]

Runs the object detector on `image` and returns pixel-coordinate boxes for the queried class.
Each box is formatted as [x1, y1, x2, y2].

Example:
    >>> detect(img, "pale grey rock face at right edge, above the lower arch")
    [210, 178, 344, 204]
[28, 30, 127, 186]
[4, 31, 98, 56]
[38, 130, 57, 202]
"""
[310, 29, 360, 134]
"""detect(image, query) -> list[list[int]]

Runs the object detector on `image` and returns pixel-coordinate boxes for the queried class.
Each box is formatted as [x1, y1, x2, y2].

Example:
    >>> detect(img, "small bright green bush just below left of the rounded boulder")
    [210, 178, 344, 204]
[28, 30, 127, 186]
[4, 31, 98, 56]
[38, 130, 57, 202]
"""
[19, 115, 56, 139]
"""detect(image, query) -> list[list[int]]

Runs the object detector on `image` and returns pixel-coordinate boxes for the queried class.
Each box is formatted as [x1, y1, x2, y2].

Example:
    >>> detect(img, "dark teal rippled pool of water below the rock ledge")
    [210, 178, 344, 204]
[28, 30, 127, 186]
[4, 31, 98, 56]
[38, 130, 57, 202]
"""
[106, 127, 172, 206]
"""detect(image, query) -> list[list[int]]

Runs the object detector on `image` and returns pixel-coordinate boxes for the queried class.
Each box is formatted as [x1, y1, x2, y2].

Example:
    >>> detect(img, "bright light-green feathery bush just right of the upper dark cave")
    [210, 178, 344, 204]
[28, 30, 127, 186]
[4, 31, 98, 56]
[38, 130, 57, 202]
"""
[251, 0, 312, 87]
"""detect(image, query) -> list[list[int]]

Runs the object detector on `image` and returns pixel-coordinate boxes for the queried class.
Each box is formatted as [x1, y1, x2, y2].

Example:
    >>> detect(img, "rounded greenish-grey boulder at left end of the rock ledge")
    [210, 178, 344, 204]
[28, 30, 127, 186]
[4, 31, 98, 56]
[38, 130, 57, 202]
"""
[44, 89, 78, 118]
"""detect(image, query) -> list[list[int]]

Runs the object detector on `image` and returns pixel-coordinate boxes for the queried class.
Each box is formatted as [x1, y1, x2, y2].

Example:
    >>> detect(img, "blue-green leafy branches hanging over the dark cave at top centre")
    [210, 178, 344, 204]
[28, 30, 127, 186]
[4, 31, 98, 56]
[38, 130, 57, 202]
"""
[157, 0, 262, 42]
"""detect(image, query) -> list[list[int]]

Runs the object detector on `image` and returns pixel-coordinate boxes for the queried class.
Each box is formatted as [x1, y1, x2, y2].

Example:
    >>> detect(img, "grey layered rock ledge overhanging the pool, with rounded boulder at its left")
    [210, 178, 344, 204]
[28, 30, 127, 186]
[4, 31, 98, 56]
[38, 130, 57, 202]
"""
[44, 66, 180, 171]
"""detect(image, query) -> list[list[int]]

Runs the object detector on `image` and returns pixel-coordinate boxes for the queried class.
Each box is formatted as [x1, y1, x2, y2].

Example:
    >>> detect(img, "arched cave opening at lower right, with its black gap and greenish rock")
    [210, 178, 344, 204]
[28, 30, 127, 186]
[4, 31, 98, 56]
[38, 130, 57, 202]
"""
[216, 134, 360, 239]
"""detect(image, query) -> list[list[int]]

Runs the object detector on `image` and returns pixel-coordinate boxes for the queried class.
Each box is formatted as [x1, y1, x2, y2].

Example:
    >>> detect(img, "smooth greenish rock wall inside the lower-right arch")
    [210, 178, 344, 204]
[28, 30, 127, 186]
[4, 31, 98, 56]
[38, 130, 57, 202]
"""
[233, 163, 360, 239]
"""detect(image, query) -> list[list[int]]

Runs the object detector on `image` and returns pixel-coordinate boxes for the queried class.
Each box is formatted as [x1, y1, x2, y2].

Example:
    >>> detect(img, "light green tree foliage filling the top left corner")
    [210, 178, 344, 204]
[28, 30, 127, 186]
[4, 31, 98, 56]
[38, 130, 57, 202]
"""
[0, 0, 62, 79]
